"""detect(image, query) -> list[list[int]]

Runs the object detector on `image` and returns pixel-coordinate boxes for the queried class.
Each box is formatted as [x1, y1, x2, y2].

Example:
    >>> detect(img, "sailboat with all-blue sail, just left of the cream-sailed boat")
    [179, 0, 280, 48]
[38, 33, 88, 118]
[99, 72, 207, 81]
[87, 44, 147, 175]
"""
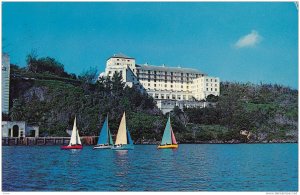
[93, 116, 114, 149]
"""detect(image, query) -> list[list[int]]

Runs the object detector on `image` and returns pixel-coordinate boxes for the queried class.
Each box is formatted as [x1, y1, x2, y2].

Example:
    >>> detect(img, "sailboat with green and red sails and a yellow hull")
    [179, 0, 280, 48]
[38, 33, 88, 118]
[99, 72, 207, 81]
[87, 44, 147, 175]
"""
[157, 115, 178, 149]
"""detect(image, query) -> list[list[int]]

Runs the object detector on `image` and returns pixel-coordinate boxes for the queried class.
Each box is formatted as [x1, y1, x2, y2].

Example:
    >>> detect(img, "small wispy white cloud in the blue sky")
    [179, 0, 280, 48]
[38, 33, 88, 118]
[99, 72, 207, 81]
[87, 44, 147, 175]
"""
[235, 30, 262, 48]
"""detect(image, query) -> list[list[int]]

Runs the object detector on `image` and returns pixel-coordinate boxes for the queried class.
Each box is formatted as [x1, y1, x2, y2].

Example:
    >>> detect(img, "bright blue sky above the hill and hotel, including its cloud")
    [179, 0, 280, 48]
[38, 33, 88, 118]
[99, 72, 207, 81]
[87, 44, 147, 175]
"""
[2, 2, 298, 89]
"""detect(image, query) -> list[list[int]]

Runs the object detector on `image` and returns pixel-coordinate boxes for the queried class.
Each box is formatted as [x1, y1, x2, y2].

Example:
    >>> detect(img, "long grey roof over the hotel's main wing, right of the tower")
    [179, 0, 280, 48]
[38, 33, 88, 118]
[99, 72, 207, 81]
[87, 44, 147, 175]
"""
[136, 64, 206, 75]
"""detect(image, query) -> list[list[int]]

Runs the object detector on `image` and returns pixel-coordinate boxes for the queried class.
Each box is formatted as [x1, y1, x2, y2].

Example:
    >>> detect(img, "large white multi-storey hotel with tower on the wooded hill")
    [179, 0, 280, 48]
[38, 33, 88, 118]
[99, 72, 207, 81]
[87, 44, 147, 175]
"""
[100, 54, 220, 113]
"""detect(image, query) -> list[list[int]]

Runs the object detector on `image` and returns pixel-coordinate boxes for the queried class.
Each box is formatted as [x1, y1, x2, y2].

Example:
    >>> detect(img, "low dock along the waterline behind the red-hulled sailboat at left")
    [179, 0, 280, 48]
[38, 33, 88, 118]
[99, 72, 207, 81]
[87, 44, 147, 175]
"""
[2, 136, 98, 146]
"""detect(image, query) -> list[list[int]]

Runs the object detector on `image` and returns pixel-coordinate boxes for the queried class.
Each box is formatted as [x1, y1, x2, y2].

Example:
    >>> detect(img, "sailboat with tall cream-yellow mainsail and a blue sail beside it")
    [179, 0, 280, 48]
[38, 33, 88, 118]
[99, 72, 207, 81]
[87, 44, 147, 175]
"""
[111, 112, 134, 150]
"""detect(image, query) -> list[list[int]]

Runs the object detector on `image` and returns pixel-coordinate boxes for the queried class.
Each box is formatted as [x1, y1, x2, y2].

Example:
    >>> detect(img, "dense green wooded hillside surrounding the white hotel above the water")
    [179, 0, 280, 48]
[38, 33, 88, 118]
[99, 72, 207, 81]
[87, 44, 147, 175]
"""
[10, 55, 298, 142]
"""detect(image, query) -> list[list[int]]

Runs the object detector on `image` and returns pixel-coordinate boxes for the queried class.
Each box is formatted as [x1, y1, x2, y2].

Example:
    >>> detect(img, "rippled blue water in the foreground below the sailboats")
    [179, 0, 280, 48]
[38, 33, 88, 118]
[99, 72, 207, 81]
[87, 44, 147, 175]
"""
[2, 144, 298, 191]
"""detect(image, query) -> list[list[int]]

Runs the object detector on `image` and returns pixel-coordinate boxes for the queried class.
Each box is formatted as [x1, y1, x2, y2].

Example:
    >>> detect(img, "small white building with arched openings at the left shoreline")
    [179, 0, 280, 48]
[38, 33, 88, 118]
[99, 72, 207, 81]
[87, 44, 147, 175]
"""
[2, 121, 39, 137]
